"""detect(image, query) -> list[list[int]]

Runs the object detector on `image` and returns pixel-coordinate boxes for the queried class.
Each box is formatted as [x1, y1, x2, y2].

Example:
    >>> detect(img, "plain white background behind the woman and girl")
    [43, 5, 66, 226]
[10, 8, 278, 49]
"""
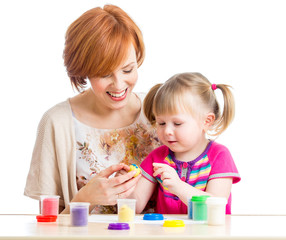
[0, 0, 286, 214]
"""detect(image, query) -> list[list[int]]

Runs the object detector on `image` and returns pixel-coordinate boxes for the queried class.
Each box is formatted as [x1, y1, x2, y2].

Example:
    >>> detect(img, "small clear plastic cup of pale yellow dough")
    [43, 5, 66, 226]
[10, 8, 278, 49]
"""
[117, 199, 136, 223]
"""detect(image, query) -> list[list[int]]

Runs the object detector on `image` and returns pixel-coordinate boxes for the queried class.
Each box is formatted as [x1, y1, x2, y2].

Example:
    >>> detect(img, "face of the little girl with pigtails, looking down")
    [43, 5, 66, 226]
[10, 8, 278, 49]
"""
[156, 113, 205, 160]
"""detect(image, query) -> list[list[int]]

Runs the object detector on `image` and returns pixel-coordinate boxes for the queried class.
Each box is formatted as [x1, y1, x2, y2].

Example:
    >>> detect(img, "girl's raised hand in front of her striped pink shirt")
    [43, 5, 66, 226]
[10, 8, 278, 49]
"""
[153, 163, 182, 194]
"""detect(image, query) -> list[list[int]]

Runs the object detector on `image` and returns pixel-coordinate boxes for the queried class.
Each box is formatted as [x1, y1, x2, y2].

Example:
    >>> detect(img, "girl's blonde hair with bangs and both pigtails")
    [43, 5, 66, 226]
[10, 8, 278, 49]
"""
[144, 73, 235, 136]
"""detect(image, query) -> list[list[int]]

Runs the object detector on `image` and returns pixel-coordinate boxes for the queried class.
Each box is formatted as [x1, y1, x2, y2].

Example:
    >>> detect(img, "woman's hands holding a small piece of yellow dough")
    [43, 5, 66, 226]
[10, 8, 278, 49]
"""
[73, 164, 140, 206]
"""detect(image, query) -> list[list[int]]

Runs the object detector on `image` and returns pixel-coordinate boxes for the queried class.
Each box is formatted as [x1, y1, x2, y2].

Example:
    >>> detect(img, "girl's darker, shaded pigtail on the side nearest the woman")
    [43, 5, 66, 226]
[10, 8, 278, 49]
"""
[143, 84, 162, 125]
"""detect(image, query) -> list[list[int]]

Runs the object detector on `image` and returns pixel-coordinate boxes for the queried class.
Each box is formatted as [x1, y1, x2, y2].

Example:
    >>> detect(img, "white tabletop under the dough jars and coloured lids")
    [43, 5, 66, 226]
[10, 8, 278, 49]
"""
[0, 215, 286, 240]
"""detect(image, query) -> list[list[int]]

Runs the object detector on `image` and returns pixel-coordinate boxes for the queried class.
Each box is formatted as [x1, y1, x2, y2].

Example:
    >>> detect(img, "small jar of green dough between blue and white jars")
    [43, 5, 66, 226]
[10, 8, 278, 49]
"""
[191, 195, 209, 221]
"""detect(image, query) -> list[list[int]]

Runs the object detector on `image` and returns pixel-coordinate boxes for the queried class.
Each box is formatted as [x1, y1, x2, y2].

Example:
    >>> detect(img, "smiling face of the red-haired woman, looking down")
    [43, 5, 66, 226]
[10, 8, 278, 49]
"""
[90, 44, 138, 110]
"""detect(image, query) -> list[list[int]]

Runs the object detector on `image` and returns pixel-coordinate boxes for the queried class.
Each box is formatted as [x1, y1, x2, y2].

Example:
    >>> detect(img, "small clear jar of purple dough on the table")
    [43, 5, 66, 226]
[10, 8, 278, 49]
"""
[70, 202, 90, 227]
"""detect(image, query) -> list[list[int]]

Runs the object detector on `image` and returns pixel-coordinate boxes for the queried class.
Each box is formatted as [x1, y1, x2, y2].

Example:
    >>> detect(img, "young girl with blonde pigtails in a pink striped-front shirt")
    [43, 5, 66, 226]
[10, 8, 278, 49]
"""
[132, 73, 240, 214]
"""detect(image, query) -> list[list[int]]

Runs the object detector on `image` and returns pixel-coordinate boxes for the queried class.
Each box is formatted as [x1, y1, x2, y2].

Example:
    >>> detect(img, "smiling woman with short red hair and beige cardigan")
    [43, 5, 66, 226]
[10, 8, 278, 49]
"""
[24, 5, 159, 213]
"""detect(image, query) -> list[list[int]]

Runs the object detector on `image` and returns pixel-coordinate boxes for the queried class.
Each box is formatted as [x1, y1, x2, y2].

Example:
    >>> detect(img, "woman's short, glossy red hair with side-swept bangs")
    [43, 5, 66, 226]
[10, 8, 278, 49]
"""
[63, 5, 145, 91]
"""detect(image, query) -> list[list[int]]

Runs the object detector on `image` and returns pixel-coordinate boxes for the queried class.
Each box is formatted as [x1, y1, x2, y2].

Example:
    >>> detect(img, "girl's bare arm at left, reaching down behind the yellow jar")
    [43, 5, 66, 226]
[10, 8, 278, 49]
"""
[128, 176, 156, 214]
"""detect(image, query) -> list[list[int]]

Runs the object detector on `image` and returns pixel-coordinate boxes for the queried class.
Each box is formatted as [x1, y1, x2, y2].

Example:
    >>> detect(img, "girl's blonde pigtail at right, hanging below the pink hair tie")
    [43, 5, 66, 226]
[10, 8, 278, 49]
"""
[213, 84, 235, 136]
